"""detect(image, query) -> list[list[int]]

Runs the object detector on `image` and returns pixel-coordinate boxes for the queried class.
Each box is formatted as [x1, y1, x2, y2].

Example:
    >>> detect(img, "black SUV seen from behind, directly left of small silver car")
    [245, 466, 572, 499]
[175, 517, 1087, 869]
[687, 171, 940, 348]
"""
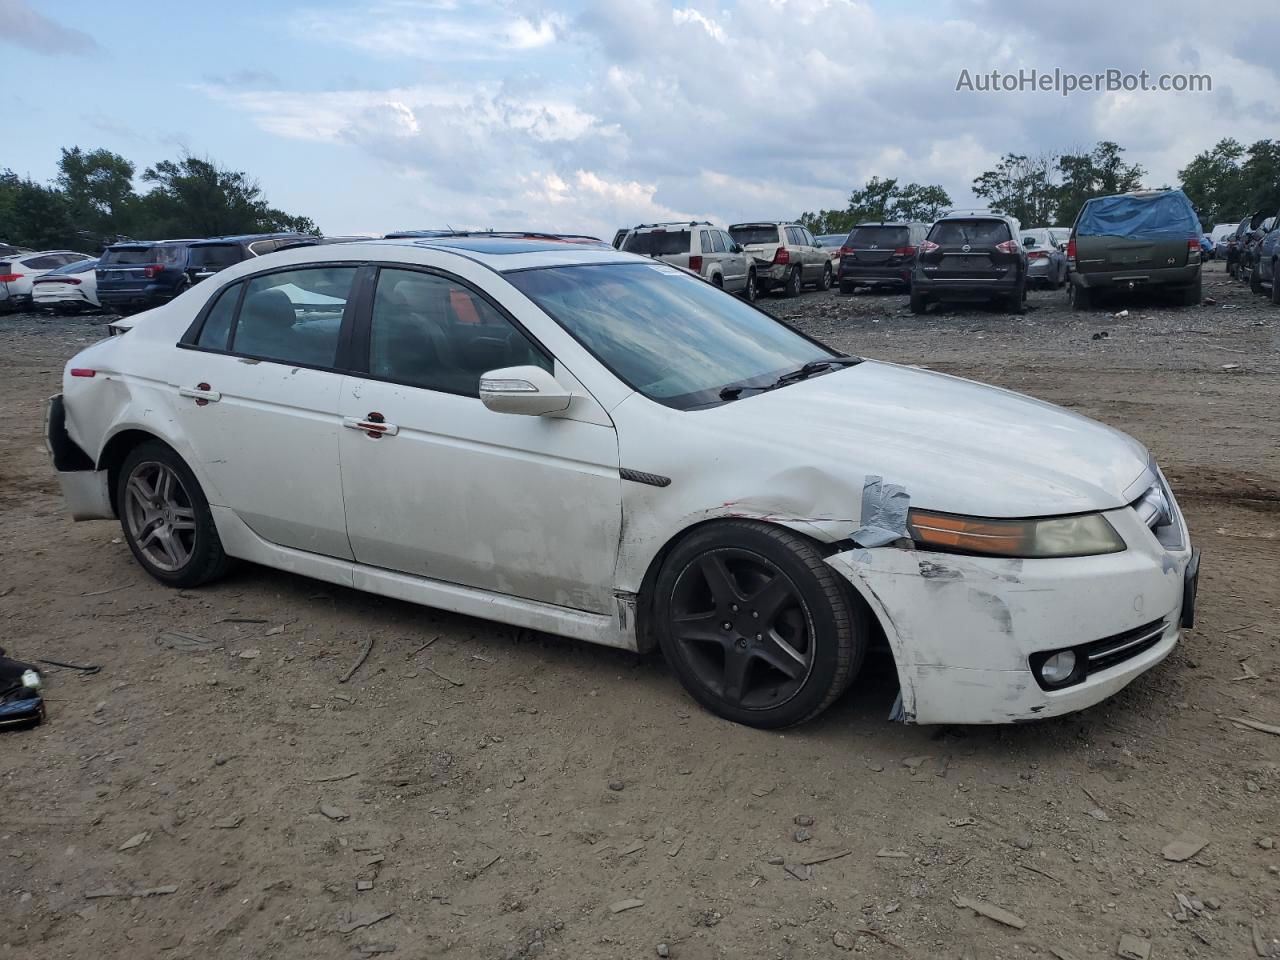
[911, 214, 1027, 314]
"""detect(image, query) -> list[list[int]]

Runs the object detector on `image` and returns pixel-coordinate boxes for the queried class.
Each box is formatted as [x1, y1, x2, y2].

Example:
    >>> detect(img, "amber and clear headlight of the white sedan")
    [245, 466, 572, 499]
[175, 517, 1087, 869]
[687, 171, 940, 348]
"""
[908, 509, 1125, 559]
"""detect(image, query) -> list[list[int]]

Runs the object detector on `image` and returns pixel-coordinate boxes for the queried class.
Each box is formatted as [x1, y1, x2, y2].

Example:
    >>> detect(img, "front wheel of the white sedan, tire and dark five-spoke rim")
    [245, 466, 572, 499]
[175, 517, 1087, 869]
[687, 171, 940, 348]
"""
[654, 520, 868, 730]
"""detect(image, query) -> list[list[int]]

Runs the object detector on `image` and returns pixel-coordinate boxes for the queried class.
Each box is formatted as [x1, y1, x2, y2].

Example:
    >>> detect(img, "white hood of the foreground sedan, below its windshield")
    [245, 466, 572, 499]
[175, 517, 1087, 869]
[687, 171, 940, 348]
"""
[707, 361, 1151, 517]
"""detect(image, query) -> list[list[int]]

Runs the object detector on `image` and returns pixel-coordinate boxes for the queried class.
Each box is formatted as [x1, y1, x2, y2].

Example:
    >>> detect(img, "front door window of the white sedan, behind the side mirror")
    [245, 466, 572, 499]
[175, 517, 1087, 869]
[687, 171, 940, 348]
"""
[369, 269, 552, 397]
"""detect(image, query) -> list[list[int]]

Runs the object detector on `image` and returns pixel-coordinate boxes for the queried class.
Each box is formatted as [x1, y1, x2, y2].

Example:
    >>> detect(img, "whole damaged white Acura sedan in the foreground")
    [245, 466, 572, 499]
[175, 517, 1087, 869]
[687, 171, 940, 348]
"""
[47, 236, 1198, 727]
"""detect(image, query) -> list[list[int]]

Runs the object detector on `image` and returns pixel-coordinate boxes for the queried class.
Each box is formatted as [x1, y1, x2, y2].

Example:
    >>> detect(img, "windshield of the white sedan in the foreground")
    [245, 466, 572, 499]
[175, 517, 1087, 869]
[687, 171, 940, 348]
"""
[507, 264, 835, 410]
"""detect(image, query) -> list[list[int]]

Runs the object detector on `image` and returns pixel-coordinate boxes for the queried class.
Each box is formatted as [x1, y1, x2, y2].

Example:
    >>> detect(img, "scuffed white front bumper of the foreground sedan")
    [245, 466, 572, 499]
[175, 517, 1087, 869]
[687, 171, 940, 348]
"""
[827, 491, 1193, 723]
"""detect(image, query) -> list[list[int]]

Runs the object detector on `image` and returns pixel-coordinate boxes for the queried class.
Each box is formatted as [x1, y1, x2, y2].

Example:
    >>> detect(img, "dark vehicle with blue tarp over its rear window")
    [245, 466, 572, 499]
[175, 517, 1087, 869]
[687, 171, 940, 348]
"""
[1066, 189, 1201, 310]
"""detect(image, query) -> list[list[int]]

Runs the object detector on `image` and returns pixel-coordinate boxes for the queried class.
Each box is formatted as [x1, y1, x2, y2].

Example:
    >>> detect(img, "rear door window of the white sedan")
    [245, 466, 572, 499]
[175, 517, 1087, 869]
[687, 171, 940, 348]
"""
[230, 266, 356, 367]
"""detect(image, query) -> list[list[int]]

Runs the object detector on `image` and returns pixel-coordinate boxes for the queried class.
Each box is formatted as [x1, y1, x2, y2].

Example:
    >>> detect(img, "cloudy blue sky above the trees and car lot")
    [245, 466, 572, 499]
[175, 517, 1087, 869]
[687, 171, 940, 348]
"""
[0, 0, 1280, 238]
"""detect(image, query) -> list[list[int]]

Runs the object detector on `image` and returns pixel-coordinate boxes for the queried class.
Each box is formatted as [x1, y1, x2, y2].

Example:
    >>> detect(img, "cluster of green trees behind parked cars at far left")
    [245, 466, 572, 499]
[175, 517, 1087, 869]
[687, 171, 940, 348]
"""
[0, 146, 319, 253]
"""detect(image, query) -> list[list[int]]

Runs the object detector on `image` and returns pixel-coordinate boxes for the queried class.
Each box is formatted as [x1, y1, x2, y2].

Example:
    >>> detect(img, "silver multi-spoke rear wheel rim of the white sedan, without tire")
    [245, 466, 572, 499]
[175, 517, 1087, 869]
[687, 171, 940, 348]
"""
[124, 460, 196, 573]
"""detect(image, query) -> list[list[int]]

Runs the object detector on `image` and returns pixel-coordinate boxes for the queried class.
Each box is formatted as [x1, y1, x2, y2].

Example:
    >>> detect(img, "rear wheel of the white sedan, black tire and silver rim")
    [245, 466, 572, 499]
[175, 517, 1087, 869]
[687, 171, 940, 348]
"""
[115, 440, 229, 586]
